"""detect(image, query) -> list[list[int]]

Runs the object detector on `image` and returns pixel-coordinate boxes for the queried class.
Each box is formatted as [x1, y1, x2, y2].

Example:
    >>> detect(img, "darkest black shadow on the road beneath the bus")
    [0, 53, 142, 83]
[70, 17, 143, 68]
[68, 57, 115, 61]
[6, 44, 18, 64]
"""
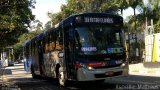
[16, 79, 115, 90]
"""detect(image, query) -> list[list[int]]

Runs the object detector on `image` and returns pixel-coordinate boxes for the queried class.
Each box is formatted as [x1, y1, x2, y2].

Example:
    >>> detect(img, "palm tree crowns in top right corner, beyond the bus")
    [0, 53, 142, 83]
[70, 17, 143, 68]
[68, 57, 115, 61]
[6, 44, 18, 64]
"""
[128, 0, 160, 32]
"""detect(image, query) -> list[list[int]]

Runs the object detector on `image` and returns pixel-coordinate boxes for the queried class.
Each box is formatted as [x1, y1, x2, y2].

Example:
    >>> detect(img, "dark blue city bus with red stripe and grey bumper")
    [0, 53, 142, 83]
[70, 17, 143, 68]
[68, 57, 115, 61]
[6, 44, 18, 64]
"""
[23, 13, 128, 86]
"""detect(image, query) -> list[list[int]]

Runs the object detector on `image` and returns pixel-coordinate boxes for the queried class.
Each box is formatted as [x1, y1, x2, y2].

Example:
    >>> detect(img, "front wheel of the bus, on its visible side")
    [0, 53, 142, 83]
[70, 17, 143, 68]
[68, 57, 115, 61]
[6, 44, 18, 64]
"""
[58, 67, 68, 87]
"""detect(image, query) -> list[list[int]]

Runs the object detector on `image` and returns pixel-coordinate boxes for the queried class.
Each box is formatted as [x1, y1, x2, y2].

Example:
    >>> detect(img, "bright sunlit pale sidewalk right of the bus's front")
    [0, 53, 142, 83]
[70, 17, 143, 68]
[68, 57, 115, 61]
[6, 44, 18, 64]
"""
[129, 62, 160, 77]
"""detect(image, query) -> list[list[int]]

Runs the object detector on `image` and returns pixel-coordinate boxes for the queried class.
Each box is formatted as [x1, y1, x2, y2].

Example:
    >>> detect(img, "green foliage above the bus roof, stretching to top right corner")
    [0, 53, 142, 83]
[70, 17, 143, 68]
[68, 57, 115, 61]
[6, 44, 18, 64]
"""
[43, 0, 160, 32]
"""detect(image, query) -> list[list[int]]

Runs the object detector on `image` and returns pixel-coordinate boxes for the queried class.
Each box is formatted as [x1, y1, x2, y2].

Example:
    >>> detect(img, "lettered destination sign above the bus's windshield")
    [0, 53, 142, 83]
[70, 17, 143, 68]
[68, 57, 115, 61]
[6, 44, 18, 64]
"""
[84, 17, 114, 24]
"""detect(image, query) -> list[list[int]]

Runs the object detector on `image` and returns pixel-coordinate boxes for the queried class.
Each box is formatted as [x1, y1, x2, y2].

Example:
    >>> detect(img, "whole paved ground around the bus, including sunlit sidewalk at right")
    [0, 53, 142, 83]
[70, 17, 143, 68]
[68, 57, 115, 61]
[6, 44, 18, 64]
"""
[0, 63, 160, 90]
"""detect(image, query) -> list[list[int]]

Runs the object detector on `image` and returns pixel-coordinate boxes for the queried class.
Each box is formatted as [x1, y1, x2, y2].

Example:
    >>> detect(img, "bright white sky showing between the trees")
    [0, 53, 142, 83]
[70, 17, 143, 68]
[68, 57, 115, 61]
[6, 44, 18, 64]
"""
[32, 0, 141, 26]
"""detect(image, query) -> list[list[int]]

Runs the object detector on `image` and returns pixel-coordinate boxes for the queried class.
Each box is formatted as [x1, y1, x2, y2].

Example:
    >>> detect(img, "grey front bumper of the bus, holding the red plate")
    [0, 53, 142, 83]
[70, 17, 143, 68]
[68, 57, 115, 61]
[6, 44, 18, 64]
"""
[77, 66, 128, 81]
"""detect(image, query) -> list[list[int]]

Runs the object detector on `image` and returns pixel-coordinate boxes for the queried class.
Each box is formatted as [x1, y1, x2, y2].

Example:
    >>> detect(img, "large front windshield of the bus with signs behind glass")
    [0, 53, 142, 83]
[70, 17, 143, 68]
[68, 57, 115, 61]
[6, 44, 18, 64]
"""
[75, 26, 123, 54]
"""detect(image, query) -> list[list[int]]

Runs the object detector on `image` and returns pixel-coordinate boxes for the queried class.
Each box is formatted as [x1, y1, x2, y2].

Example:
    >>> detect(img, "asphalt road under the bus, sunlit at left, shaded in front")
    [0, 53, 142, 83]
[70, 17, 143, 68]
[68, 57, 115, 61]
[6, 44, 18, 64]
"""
[1, 64, 160, 90]
